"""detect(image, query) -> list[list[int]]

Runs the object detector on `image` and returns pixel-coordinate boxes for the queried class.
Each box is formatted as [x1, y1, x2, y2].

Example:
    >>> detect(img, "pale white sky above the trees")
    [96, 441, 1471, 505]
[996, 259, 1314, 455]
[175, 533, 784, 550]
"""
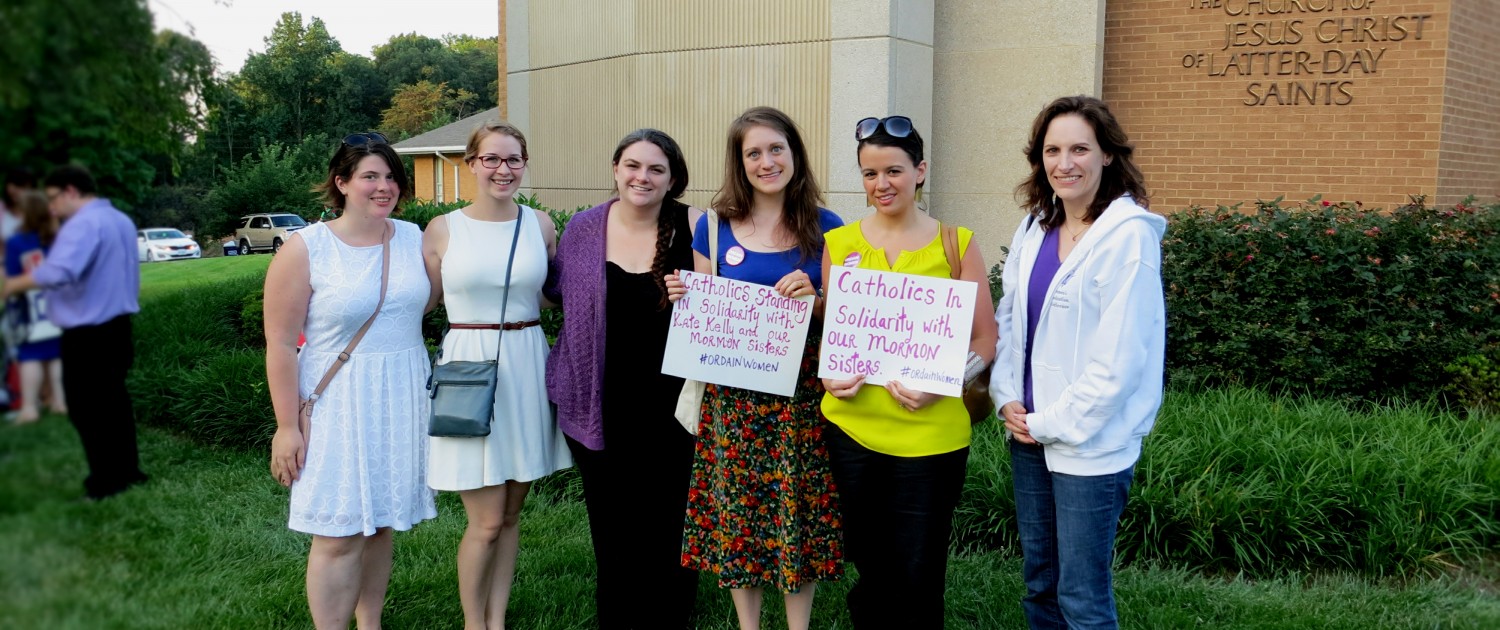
[147, 0, 500, 74]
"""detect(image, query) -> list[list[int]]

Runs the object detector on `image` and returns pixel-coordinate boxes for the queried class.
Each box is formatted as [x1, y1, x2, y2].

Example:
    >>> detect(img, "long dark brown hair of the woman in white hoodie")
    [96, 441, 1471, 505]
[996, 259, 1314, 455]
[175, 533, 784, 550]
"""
[1016, 96, 1151, 230]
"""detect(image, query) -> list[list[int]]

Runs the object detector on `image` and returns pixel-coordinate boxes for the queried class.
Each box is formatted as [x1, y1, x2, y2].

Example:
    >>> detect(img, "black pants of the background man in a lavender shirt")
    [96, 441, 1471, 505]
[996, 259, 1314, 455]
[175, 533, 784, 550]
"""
[62, 315, 146, 500]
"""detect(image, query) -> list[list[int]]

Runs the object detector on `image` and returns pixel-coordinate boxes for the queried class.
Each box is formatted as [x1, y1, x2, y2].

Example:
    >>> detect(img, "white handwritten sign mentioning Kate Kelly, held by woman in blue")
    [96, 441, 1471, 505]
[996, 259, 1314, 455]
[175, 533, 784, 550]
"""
[662, 272, 813, 396]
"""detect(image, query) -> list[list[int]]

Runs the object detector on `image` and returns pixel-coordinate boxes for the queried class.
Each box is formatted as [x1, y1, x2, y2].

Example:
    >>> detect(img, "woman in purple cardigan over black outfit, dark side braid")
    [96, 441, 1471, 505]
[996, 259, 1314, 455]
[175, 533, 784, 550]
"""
[545, 129, 701, 630]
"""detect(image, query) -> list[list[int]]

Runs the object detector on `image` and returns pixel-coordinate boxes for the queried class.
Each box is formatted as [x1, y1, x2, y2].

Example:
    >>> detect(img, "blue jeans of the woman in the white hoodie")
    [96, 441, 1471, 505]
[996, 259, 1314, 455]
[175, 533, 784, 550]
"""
[1010, 440, 1136, 630]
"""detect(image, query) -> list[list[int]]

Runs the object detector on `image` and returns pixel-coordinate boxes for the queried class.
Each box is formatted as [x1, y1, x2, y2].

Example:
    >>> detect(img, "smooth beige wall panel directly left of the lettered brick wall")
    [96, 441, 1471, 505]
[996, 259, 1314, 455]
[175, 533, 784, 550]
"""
[929, 0, 1104, 253]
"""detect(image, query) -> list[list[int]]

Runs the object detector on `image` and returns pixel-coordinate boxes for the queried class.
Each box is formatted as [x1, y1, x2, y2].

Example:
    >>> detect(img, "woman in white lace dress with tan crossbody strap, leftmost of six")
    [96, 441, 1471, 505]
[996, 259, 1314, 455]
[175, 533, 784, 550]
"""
[266, 134, 437, 629]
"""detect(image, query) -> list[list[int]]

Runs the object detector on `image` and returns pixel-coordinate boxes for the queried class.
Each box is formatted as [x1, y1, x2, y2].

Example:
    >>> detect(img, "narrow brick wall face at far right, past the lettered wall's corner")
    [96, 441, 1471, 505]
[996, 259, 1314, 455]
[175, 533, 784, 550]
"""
[1437, 0, 1500, 204]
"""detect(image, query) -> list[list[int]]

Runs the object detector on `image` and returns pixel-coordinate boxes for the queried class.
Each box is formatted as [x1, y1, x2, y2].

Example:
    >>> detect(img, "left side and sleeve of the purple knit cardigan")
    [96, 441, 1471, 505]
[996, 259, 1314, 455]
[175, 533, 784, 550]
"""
[542, 200, 615, 450]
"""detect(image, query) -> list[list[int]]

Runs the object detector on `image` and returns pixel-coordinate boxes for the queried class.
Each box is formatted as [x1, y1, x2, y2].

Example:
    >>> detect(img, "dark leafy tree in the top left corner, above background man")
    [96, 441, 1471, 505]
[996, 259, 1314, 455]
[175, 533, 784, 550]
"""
[0, 0, 203, 206]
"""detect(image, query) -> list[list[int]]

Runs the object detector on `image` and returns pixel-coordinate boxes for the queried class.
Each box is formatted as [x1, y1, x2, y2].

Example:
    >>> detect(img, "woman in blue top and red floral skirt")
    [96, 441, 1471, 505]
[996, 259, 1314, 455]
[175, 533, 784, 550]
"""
[671, 107, 843, 630]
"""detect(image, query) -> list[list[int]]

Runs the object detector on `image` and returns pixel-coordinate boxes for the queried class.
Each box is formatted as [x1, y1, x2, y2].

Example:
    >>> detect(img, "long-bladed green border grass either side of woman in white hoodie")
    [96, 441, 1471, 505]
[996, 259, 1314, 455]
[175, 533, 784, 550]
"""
[954, 389, 1500, 576]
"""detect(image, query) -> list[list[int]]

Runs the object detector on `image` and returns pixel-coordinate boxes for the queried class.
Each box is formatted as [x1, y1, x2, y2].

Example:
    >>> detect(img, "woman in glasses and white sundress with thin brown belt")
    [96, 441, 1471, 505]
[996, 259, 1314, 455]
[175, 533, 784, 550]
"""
[423, 120, 573, 629]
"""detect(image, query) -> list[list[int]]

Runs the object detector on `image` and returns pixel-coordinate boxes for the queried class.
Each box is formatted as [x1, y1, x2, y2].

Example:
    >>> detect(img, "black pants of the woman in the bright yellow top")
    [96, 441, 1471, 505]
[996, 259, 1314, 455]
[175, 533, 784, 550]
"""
[824, 423, 969, 630]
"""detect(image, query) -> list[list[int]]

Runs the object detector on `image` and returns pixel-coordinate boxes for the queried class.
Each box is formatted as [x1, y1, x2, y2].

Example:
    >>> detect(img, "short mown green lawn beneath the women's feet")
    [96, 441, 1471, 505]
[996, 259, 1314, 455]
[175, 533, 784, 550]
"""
[0, 417, 1500, 630]
